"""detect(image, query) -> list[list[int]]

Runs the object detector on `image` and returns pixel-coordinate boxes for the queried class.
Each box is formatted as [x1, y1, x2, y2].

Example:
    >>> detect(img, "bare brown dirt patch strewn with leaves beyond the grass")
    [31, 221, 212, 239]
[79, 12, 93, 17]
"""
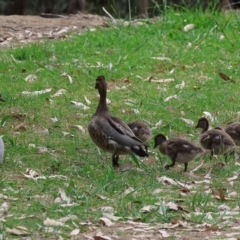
[0, 14, 109, 46]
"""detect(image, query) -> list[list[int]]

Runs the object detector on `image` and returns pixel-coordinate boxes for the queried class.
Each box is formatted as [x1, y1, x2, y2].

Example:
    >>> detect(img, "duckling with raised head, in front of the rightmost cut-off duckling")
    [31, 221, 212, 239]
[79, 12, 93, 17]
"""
[196, 117, 236, 161]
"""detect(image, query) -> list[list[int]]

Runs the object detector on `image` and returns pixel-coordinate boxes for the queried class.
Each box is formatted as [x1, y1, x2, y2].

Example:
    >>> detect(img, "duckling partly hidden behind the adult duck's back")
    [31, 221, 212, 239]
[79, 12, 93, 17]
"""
[128, 121, 152, 143]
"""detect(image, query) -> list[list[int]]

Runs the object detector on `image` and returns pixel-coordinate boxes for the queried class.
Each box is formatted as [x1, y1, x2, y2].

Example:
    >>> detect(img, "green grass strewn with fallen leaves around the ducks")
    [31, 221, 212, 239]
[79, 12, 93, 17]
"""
[0, 7, 240, 239]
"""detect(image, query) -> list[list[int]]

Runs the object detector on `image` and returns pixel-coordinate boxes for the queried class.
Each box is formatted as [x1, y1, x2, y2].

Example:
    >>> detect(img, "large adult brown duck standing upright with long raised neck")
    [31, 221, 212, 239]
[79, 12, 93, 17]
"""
[88, 76, 149, 167]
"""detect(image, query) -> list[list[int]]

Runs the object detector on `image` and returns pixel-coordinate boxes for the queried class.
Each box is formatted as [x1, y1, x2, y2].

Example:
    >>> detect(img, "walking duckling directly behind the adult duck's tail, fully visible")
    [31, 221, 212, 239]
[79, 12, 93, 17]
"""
[154, 134, 205, 172]
